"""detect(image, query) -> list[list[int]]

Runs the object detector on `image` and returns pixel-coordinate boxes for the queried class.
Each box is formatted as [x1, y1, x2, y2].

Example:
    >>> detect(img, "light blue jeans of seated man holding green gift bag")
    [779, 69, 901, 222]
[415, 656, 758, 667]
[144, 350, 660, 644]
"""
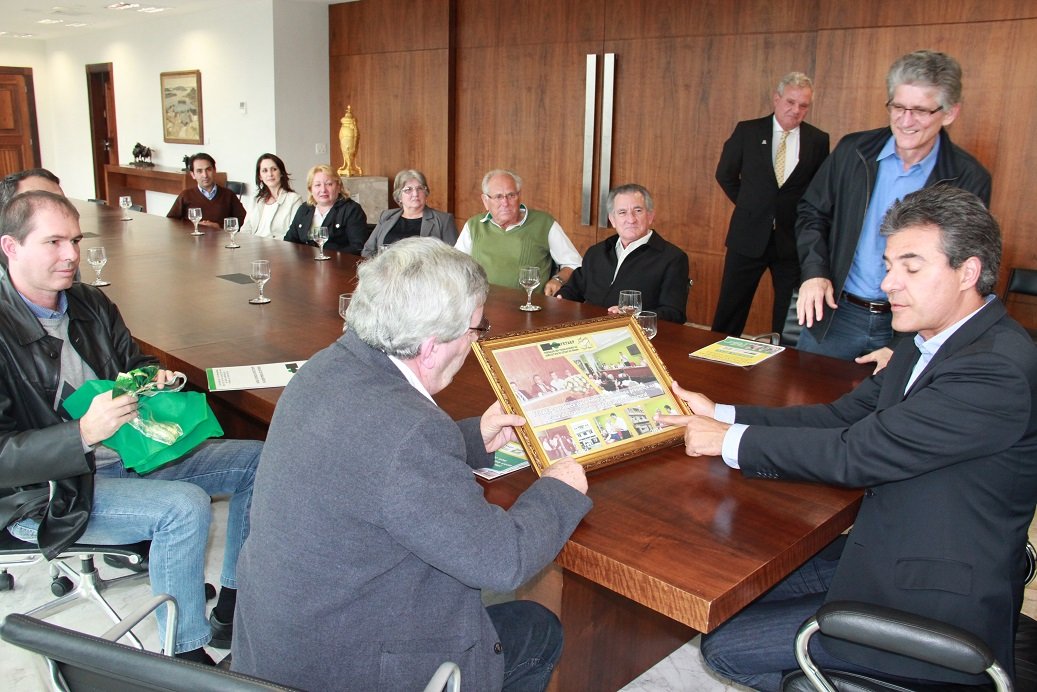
[8, 440, 262, 654]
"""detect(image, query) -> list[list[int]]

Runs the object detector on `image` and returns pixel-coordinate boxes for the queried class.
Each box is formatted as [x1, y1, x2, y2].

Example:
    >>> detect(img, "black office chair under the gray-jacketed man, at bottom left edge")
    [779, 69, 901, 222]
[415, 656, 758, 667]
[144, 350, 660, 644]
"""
[0, 610, 460, 692]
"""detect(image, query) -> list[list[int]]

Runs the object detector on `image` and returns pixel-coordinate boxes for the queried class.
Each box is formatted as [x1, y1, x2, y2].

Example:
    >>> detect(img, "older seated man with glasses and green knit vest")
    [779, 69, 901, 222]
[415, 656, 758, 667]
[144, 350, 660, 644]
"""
[454, 168, 582, 296]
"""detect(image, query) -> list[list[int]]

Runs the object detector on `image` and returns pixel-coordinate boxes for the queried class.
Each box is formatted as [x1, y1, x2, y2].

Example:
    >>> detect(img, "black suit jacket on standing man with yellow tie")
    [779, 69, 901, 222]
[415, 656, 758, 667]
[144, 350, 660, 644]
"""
[717, 114, 829, 258]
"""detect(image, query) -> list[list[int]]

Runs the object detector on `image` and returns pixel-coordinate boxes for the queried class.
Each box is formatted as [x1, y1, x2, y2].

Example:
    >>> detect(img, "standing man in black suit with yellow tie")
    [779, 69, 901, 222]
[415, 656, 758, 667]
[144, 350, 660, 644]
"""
[712, 72, 829, 336]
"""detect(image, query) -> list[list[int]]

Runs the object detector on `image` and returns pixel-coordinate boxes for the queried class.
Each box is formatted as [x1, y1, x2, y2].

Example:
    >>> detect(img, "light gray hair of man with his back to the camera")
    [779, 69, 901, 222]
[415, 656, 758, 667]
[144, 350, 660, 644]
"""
[345, 238, 489, 359]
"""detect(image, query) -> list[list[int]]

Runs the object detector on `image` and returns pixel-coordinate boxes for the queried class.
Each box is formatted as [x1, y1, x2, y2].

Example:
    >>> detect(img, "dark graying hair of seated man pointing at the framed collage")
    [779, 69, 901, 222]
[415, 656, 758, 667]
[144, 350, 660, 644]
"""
[879, 185, 1001, 296]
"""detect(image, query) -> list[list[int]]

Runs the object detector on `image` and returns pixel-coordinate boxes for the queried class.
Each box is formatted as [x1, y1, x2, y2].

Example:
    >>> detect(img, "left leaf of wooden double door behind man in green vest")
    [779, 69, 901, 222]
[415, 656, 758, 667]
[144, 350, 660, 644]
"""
[453, 0, 604, 251]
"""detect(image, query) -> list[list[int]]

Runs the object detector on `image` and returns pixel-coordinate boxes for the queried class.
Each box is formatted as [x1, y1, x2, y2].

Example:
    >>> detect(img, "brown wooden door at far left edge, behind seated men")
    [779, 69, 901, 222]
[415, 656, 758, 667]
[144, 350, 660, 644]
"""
[0, 67, 39, 175]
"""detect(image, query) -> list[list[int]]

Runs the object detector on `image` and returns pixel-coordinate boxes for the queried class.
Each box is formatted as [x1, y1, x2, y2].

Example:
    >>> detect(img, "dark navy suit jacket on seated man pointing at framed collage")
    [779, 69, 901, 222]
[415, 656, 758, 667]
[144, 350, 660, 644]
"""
[735, 300, 1037, 683]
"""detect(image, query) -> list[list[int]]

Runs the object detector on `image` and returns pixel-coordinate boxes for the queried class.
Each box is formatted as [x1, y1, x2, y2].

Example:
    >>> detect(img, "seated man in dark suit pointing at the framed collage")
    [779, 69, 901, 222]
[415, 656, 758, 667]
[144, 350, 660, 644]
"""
[657, 185, 1037, 690]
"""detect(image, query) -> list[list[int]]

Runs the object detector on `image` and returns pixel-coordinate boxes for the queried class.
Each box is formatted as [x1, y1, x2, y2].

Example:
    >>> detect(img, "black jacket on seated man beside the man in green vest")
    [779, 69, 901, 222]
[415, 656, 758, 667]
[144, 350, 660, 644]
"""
[558, 231, 689, 324]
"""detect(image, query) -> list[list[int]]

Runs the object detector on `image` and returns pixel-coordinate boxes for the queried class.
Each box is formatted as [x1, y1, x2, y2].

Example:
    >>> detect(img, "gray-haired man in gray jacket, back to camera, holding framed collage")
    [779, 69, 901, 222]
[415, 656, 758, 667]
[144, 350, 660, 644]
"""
[231, 238, 591, 690]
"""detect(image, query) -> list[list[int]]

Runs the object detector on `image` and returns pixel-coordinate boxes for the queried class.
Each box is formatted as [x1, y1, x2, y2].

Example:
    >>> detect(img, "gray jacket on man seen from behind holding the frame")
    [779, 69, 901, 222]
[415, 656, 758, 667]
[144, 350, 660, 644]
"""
[232, 331, 591, 691]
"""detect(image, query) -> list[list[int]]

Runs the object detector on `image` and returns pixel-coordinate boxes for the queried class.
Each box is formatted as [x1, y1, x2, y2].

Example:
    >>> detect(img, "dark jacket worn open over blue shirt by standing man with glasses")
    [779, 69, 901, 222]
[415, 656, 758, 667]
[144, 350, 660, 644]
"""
[795, 128, 990, 341]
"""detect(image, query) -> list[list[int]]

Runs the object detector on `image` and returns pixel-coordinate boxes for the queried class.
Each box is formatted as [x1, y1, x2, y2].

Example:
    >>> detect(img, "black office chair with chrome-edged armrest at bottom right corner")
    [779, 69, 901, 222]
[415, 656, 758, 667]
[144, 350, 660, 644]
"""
[782, 543, 1037, 692]
